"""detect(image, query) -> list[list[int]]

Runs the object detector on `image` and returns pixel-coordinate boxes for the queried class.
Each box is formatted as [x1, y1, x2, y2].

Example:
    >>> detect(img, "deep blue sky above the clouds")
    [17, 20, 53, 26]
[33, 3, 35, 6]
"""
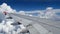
[0, 0, 60, 11]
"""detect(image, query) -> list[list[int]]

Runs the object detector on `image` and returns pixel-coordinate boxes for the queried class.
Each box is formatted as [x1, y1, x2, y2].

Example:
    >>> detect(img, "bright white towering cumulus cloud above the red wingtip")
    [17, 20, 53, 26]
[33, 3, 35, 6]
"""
[0, 3, 16, 13]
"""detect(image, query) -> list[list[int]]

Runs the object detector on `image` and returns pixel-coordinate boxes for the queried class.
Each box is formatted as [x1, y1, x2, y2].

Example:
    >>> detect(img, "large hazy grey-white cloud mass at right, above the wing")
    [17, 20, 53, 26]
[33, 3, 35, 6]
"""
[40, 7, 60, 20]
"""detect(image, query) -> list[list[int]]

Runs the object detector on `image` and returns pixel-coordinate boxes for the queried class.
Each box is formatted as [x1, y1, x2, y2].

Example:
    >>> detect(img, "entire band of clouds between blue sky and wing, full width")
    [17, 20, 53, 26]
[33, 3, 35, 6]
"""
[0, 3, 60, 19]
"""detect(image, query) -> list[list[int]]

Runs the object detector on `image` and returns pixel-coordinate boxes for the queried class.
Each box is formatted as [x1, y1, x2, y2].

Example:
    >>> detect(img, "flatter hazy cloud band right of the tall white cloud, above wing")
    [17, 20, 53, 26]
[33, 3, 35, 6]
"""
[19, 7, 60, 20]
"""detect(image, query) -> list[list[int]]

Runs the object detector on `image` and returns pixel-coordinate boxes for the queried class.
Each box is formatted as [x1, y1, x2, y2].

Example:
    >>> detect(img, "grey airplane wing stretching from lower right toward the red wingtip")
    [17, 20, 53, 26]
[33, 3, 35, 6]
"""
[9, 13, 60, 34]
